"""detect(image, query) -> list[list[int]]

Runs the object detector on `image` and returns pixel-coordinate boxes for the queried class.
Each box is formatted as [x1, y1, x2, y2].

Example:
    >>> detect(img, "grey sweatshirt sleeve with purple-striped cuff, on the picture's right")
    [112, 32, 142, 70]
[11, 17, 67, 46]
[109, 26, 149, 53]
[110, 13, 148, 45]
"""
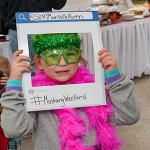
[106, 74, 140, 125]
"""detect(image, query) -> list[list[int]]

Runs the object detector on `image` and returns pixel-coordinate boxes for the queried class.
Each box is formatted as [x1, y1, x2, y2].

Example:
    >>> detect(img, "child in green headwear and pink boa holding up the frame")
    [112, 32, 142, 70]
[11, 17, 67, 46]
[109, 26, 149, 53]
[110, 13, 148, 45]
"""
[1, 34, 139, 150]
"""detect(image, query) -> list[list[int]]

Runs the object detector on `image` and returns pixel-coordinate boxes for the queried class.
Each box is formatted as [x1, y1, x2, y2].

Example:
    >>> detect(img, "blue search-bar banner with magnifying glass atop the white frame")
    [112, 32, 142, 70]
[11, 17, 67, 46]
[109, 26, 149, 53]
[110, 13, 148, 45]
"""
[16, 11, 99, 24]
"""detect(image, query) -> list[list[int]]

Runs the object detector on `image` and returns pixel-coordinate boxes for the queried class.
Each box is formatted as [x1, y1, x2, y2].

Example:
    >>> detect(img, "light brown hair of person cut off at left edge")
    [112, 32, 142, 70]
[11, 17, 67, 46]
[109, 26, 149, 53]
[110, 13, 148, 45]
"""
[0, 56, 10, 76]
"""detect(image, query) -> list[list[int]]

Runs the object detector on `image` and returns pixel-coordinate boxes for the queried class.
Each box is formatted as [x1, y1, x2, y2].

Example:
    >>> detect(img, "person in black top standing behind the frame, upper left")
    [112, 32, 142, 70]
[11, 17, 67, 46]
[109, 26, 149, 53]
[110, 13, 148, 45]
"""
[0, 0, 67, 57]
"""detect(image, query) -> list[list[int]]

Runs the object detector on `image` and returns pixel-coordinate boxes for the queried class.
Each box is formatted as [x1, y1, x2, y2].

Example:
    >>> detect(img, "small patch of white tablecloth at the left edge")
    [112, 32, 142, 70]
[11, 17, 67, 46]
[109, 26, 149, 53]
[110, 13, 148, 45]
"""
[0, 42, 12, 60]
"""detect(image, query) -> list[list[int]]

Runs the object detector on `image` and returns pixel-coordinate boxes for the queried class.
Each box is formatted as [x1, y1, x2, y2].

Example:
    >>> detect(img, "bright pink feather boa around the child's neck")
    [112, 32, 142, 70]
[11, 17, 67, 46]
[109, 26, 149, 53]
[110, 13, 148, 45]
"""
[32, 67, 122, 150]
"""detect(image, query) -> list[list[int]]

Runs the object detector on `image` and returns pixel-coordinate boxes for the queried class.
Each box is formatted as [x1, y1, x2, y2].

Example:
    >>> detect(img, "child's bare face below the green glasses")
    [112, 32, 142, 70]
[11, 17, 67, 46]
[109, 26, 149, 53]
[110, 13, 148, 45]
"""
[37, 55, 78, 82]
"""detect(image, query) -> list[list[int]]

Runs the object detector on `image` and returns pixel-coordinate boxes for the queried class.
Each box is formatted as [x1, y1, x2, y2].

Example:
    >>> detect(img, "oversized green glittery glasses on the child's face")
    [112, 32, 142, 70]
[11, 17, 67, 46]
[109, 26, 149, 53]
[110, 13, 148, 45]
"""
[40, 48, 81, 66]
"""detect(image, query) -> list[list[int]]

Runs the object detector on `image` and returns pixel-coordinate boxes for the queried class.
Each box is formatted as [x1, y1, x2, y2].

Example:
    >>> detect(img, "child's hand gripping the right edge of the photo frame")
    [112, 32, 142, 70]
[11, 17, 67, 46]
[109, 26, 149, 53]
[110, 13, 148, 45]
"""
[98, 48, 117, 71]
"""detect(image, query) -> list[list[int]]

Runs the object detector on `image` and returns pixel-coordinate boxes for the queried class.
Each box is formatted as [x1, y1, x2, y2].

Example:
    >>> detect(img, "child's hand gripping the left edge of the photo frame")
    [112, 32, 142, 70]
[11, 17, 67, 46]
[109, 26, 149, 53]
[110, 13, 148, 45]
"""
[9, 50, 32, 80]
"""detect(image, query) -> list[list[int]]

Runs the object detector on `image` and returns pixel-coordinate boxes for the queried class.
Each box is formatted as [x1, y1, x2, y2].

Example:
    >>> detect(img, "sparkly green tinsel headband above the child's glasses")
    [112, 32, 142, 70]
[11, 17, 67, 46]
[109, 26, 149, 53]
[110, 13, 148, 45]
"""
[32, 33, 81, 55]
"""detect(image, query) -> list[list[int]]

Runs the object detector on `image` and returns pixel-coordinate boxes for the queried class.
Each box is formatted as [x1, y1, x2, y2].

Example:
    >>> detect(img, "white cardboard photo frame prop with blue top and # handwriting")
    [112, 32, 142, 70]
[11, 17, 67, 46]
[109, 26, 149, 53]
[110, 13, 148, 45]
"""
[16, 11, 106, 111]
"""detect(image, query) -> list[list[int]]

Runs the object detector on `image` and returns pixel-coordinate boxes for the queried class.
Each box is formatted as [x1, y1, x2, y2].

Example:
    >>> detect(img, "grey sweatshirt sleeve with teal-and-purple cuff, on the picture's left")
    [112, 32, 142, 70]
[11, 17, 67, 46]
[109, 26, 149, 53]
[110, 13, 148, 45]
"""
[0, 80, 36, 139]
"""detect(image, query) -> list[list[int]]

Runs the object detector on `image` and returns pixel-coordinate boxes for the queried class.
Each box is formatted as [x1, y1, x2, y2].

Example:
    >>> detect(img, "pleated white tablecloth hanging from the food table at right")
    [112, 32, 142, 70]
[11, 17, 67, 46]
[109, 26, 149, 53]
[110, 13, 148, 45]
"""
[101, 18, 150, 78]
